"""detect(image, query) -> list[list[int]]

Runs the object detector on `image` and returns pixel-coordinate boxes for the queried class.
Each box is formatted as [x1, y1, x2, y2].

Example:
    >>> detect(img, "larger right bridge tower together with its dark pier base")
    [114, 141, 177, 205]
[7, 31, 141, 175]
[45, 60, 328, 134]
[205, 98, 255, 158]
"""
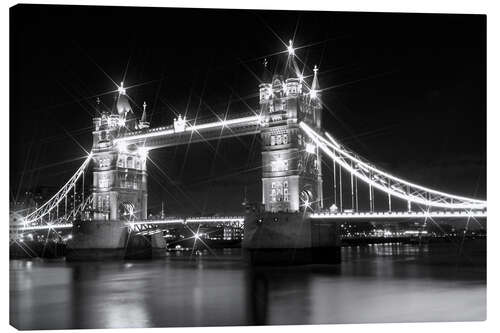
[247, 63, 340, 264]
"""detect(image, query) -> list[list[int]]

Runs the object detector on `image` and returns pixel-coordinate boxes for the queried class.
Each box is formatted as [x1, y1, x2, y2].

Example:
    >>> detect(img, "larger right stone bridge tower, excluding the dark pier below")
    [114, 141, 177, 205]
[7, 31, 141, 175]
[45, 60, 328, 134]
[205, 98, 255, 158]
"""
[259, 53, 323, 212]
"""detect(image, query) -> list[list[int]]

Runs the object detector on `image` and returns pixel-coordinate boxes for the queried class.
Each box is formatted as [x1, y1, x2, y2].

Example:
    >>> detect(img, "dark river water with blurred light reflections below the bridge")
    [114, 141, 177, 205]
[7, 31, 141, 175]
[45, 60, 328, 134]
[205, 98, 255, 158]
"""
[10, 241, 486, 329]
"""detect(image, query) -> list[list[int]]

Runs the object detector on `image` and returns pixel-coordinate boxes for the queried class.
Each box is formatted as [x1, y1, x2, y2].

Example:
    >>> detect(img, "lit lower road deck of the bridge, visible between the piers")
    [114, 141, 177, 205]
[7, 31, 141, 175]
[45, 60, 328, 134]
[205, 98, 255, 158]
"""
[13, 211, 486, 232]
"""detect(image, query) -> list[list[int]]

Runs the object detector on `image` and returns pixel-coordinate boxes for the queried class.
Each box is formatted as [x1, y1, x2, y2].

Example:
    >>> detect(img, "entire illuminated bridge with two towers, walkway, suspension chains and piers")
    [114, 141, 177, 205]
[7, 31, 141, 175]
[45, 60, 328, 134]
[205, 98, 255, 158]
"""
[11, 39, 486, 262]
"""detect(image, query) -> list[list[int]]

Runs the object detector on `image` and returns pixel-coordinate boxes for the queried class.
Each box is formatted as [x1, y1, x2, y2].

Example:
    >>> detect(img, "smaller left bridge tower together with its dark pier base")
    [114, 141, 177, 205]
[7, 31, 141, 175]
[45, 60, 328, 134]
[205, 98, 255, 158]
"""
[66, 87, 166, 261]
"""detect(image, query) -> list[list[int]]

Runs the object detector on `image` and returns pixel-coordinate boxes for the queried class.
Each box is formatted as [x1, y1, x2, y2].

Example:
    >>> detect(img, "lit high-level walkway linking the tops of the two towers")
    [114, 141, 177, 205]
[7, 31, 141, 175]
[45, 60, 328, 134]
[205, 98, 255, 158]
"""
[115, 111, 262, 149]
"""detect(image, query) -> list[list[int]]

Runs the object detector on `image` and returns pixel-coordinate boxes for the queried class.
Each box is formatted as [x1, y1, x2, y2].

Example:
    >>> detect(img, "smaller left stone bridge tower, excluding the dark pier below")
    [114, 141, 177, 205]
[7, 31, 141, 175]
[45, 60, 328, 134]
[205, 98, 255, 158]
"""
[92, 84, 149, 221]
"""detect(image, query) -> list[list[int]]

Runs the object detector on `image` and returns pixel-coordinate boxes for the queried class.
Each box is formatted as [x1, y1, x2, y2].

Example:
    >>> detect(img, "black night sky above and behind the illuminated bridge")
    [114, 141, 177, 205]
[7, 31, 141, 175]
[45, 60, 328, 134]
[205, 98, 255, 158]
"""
[10, 5, 486, 215]
